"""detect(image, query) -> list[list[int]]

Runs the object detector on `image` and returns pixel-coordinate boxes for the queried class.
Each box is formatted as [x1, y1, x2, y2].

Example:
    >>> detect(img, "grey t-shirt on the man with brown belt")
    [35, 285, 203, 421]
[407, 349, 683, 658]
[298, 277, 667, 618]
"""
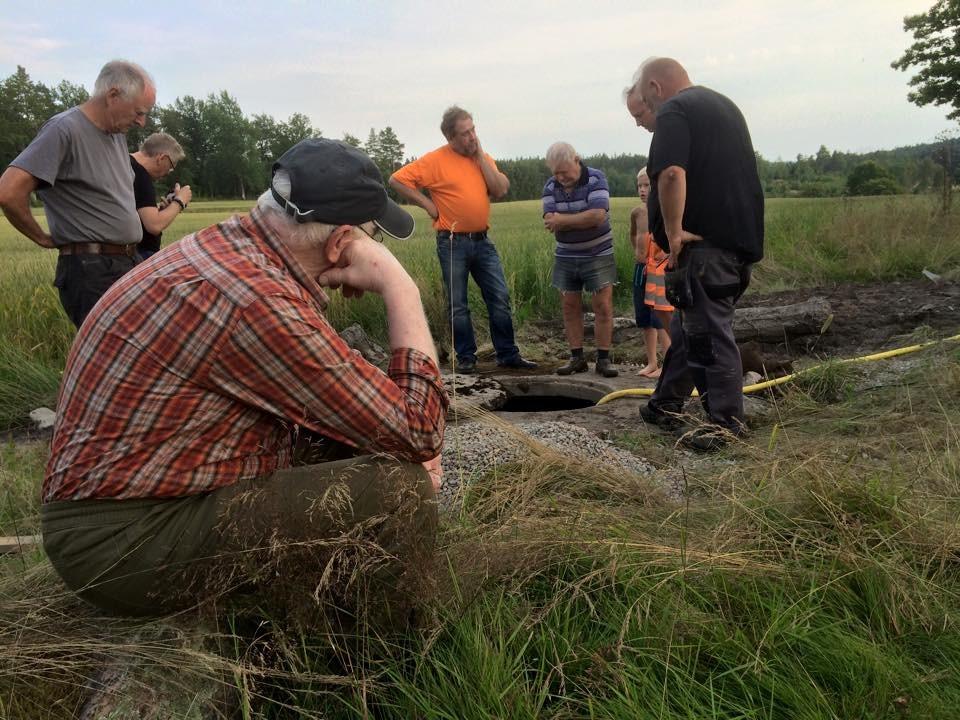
[10, 107, 143, 246]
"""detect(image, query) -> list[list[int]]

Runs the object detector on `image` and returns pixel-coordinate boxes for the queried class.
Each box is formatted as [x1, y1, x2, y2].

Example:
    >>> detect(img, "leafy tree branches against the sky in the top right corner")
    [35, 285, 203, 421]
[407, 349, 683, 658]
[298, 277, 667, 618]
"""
[891, 0, 960, 120]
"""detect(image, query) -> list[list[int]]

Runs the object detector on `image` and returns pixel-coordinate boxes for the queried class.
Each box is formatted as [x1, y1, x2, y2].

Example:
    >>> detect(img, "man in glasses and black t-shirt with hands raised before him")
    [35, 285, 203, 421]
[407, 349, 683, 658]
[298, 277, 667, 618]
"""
[130, 133, 193, 260]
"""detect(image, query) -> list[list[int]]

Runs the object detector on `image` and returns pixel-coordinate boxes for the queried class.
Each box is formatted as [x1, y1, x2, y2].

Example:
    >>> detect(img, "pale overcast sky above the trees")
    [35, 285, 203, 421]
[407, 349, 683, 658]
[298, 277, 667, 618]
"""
[0, 0, 956, 159]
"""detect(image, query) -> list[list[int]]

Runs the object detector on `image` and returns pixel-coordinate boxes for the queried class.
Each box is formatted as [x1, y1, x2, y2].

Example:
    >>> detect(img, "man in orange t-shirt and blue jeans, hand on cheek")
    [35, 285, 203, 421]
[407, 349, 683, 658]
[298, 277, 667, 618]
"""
[390, 106, 537, 373]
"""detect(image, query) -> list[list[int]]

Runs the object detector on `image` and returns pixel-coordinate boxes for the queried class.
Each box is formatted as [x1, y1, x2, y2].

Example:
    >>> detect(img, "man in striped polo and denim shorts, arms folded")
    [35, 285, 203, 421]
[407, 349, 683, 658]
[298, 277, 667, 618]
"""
[543, 142, 617, 377]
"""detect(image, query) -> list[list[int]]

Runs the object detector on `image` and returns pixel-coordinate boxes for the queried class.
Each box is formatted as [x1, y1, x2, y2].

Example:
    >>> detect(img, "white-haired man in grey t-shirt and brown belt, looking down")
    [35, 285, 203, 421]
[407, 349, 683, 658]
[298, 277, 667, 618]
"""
[0, 60, 156, 328]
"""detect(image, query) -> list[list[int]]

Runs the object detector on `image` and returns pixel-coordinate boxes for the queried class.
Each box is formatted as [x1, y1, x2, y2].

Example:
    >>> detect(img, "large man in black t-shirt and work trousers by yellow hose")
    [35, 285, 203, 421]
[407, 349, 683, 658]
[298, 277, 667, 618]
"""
[625, 58, 763, 451]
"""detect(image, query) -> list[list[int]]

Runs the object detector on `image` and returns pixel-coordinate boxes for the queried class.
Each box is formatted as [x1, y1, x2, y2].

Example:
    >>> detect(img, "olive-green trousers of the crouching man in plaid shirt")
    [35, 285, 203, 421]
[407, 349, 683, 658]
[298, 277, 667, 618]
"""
[41, 455, 437, 615]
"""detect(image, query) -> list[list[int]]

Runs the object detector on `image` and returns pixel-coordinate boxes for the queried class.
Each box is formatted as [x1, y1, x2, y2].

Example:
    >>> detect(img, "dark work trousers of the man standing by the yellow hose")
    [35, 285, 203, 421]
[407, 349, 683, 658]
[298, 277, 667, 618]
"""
[649, 243, 750, 434]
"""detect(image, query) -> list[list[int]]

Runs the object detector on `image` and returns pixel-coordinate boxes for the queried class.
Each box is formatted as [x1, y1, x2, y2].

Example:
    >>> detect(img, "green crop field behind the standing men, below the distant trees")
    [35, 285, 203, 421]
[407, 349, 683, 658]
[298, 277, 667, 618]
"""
[0, 196, 960, 427]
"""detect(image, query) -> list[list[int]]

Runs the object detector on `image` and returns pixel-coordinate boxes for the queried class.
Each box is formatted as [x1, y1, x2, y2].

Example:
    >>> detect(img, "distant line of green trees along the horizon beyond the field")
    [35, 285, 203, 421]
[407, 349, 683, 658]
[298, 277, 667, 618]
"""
[0, 66, 960, 201]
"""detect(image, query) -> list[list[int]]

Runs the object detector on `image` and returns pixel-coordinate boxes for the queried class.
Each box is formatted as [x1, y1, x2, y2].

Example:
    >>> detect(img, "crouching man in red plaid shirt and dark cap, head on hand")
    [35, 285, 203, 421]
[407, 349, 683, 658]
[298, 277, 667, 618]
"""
[41, 139, 447, 615]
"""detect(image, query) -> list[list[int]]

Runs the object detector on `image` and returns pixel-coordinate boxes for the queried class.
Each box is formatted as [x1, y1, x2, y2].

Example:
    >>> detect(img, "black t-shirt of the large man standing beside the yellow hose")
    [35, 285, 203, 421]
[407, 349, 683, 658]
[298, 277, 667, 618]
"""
[647, 86, 763, 262]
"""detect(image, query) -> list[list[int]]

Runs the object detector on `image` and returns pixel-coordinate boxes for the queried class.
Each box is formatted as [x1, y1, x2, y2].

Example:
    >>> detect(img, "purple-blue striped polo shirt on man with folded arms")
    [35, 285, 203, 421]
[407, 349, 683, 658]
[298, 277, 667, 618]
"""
[543, 163, 613, 257]
